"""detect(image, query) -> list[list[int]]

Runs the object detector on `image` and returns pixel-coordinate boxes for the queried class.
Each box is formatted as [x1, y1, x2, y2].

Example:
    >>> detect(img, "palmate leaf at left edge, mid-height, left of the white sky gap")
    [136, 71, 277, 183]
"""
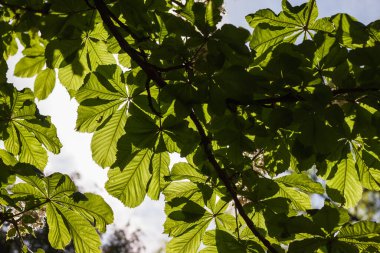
[0, 85, 62, 170]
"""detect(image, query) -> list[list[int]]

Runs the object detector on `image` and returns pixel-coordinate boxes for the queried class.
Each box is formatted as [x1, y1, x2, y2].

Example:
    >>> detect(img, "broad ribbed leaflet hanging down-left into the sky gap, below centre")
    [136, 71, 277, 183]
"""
[106, 149, 152, 207]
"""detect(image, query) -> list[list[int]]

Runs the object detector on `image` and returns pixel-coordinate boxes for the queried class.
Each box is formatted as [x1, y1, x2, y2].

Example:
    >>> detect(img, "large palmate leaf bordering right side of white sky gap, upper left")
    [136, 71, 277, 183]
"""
[76, 65, 129, 167]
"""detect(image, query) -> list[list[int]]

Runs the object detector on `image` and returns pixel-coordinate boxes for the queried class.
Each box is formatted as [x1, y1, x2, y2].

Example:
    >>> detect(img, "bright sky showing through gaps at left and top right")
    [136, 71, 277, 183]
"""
[8, 0, 380, 253]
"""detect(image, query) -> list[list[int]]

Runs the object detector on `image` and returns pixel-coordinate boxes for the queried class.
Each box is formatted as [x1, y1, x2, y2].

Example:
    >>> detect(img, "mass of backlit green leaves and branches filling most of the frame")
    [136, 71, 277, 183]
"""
[0, 0, 380, 253]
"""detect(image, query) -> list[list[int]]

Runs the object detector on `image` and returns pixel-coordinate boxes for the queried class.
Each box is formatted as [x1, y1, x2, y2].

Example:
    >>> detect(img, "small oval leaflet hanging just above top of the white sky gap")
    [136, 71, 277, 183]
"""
[34, 68, 55, 100]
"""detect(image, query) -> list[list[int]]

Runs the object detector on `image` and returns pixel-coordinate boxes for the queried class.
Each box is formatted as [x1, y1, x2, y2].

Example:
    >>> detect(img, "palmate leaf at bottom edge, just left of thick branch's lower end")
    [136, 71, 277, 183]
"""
[164, 182, 229, 252]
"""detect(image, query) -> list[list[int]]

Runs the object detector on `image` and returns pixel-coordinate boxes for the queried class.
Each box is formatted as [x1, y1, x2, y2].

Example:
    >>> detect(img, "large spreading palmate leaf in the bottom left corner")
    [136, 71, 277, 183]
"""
[12, 173, 113, 253]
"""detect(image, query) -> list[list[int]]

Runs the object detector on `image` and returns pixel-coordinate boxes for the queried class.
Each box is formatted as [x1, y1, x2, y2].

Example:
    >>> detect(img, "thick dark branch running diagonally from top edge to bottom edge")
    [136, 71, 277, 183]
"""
[94, 0, 277, 253]
